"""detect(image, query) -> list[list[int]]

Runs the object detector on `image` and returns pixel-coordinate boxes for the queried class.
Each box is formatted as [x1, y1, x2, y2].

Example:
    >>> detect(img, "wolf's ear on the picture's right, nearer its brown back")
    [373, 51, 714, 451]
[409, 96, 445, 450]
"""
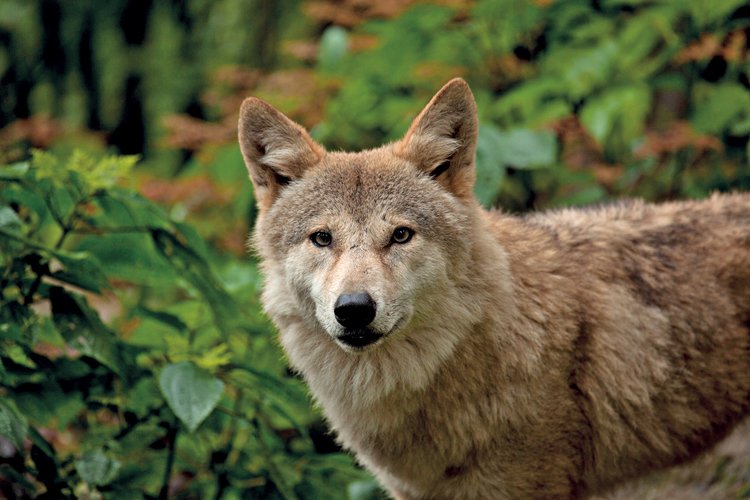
[394, 78, 478, 198]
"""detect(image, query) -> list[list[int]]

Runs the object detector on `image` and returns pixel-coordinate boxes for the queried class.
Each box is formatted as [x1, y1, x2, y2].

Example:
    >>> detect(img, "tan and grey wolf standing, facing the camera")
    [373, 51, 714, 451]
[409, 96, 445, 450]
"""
[239, 79, 750, 499]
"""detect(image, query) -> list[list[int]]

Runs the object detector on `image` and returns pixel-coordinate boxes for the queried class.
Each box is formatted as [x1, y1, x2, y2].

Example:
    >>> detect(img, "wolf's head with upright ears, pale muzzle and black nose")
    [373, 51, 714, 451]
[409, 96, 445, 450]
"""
[239, 79, 484, 360]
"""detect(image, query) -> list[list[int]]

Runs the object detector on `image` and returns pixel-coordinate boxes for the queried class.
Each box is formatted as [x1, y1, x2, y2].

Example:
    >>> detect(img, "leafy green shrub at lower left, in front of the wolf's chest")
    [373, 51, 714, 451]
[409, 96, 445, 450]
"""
[0, 152, 374, 498]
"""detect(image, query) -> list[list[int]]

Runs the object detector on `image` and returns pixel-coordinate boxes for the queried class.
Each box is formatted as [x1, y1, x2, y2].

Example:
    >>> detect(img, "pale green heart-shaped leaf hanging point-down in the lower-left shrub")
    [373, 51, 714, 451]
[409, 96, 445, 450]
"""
[159, 361, 224, 432]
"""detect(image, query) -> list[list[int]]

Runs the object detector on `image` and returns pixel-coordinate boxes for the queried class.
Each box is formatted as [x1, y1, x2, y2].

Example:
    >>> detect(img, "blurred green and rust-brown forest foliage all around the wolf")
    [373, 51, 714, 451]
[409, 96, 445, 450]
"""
[0, 0, 750, 499]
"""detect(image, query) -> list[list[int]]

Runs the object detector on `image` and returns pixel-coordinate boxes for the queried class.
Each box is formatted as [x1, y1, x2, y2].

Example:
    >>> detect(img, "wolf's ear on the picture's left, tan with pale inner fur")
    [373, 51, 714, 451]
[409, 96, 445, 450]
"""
[239, 97, 325, 209]
